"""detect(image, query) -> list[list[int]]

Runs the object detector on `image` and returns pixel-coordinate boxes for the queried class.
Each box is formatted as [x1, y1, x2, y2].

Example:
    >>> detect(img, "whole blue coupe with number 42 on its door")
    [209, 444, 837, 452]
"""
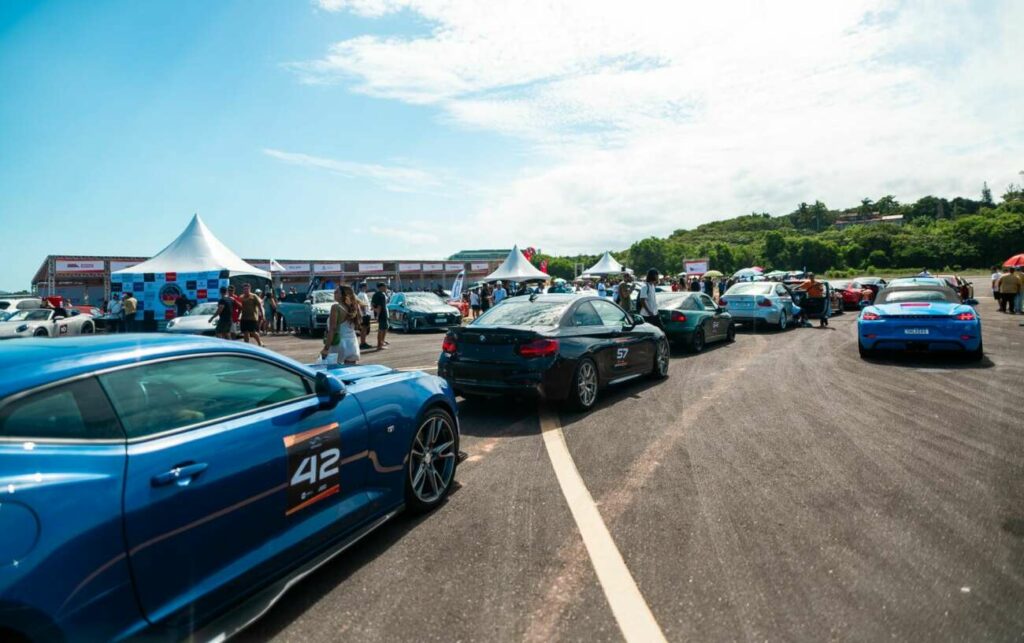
[0, 335, 460, 642]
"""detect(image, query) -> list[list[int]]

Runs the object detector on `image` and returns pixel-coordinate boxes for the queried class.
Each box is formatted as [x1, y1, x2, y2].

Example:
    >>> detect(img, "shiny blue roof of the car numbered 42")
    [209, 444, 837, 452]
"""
[0, 333, 307, 398]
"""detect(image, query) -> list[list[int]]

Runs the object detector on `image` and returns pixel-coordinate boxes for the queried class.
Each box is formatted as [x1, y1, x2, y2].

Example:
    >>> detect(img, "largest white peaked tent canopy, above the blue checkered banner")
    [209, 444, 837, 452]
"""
[114, 214, 270, 280]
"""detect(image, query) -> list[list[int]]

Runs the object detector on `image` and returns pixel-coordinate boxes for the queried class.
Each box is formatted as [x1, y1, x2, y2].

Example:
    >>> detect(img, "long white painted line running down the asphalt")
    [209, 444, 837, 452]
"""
[540, 408, 666, 643]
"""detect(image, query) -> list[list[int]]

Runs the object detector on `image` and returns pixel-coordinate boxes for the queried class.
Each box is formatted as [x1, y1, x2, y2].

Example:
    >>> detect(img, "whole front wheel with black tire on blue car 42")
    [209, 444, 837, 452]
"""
[406, 406, 459, 513]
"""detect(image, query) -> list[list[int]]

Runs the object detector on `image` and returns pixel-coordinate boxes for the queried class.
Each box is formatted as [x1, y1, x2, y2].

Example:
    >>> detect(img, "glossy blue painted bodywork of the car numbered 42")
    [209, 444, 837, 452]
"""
[0, 335, 457, 640]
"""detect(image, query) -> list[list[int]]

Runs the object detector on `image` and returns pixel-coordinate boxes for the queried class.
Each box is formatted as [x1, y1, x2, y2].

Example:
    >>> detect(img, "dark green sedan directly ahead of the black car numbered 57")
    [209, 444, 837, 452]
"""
[657, 293, 736, 353]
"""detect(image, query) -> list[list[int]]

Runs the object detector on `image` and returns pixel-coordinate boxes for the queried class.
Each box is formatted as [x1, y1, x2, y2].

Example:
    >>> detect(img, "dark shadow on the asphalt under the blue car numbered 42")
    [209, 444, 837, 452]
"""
[231, 489, 462, 643]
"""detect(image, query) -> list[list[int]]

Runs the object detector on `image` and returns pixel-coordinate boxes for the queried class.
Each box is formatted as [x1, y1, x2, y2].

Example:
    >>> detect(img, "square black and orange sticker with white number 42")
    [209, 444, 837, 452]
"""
[285, 422, 341, 516]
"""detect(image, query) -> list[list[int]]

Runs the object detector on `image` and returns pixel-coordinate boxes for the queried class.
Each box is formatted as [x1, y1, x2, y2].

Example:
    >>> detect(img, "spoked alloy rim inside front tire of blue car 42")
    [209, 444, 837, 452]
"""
[409, 414, 456, 504]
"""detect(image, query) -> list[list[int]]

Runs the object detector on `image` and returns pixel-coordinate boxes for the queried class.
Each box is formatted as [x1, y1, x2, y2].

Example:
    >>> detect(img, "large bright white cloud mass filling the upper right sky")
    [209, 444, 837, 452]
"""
[292, 0, 1024, 251]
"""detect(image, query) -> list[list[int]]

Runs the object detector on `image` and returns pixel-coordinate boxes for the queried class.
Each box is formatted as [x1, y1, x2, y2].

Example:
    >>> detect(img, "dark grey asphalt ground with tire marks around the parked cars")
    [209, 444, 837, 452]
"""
[240, 286, 1024, 642]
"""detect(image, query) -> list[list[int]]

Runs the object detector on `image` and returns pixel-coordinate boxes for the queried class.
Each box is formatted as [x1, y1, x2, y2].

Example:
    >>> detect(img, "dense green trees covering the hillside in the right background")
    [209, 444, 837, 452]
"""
[535, 185, 1024, 278]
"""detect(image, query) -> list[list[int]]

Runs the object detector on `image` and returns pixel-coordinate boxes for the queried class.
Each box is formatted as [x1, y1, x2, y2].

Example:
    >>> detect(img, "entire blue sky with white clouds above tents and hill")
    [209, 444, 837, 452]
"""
[0, 0, 1024, 289]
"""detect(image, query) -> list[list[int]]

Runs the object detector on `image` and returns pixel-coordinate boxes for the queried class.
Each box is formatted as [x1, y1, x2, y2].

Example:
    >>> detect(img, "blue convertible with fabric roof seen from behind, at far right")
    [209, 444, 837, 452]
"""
[857, 284, 984, 359]
